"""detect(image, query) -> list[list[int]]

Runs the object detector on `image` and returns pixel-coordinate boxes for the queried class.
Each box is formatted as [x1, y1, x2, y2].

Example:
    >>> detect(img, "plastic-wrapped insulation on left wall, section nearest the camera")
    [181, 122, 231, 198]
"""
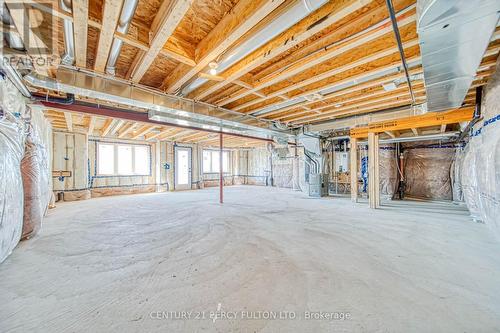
[0, 76, 24, 262]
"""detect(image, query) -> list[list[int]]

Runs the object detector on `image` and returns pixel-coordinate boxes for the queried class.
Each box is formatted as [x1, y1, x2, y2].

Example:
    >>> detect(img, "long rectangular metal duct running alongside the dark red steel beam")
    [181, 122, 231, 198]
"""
[24, 67, 294, 139]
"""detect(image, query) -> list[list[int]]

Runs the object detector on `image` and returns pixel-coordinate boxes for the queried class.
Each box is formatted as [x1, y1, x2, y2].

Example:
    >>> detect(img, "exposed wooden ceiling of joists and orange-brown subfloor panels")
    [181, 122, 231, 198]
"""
[12, 0, 500, 131]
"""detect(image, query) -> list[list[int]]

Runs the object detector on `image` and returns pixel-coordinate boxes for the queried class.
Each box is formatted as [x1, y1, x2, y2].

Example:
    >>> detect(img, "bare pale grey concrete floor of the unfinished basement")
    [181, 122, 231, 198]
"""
[0, 186, 500, 333]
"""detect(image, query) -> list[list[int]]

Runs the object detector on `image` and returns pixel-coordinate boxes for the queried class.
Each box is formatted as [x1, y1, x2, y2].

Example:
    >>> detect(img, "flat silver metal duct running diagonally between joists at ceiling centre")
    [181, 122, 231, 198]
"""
[182, 0, 328, 95]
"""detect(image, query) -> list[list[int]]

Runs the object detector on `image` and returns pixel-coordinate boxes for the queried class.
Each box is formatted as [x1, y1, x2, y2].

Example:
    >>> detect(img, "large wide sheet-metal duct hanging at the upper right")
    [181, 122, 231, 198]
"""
[417, 0, 500, 111]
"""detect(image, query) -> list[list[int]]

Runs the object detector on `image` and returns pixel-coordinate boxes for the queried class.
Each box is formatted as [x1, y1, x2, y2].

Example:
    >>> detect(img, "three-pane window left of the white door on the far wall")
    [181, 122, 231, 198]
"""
[96, 142, 151, 176]
